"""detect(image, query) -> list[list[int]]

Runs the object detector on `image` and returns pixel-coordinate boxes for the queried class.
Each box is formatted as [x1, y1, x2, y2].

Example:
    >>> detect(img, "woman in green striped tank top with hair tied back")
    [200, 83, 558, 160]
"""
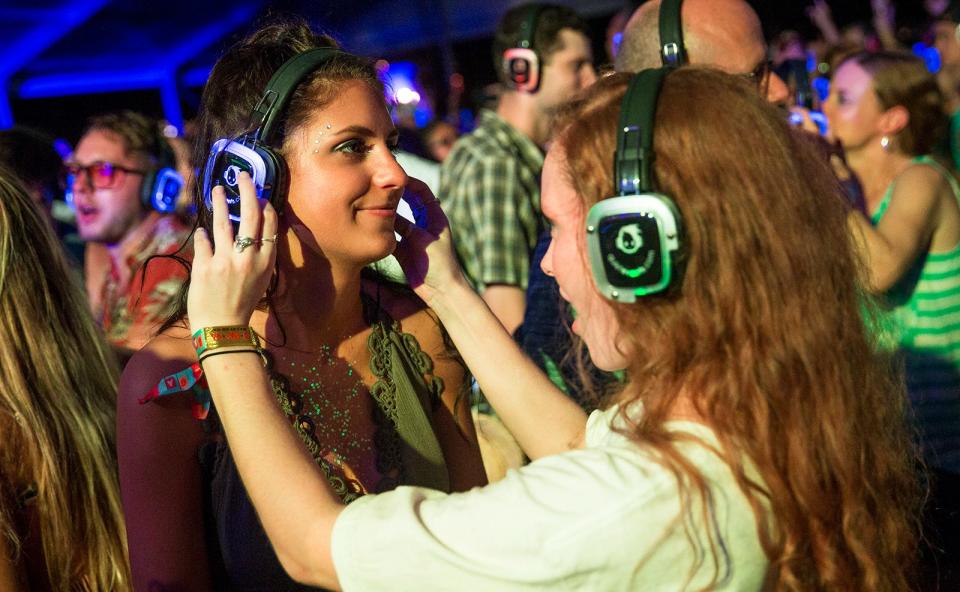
[824, 52, 960, 473]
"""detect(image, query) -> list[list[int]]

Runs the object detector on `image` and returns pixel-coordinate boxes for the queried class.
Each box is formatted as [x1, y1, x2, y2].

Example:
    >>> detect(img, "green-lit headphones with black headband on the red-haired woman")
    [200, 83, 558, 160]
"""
[587, 68, 682, 302]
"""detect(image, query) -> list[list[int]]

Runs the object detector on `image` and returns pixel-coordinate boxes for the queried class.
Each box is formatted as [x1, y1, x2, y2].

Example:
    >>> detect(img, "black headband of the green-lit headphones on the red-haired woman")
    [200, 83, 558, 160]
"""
[614, 68, 670, 195]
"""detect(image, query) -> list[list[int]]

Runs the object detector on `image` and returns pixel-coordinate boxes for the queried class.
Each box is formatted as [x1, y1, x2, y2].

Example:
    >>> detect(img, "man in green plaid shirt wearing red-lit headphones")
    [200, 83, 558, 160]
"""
[439, 4, 596, 333]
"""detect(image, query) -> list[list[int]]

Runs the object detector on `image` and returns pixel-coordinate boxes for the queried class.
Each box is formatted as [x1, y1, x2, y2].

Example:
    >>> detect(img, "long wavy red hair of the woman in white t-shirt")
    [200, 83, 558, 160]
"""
[558, 68, 920, 591]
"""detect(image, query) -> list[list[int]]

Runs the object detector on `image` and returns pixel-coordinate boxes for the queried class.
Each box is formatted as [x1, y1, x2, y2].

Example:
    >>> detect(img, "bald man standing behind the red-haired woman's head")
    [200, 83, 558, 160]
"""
[516, 0, 789, 402]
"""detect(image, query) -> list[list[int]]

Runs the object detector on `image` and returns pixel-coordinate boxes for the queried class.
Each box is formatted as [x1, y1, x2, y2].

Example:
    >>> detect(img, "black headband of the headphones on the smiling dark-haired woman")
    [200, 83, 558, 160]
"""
[248, 47, 343, 144]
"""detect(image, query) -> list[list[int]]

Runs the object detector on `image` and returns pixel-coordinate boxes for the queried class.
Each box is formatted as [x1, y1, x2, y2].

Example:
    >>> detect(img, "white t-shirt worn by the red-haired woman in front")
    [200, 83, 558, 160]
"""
[333, 407, 767, 592]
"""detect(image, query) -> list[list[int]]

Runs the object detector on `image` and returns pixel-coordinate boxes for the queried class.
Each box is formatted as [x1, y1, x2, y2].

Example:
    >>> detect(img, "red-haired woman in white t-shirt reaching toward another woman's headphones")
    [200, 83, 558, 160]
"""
[182, 68, 919, 591]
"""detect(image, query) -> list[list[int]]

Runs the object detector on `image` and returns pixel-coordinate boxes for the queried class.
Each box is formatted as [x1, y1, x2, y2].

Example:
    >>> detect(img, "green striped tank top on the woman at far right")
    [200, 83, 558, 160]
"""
[871, 156, 960, 473]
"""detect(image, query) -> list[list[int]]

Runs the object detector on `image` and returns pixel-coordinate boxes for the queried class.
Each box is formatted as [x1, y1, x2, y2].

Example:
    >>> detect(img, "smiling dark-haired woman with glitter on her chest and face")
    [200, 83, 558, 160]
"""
[118, 22, 485, 590]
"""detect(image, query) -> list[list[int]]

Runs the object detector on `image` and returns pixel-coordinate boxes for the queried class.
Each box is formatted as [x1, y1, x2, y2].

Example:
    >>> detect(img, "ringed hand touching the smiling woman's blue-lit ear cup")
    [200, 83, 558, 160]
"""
[187, 172, 277, 331]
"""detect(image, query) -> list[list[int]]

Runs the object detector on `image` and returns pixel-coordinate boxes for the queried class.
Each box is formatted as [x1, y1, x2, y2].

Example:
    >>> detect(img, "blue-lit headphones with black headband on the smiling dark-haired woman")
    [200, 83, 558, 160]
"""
[203, 47, 344, 222]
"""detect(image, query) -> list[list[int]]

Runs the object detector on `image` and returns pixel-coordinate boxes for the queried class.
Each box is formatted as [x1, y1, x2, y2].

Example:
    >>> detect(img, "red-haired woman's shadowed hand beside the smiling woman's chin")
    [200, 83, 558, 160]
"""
[394, 177, 466, 305]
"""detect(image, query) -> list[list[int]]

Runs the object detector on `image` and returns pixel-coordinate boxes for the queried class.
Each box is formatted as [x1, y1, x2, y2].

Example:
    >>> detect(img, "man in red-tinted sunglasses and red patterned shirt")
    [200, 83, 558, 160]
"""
[64, 111, 189, 358]
